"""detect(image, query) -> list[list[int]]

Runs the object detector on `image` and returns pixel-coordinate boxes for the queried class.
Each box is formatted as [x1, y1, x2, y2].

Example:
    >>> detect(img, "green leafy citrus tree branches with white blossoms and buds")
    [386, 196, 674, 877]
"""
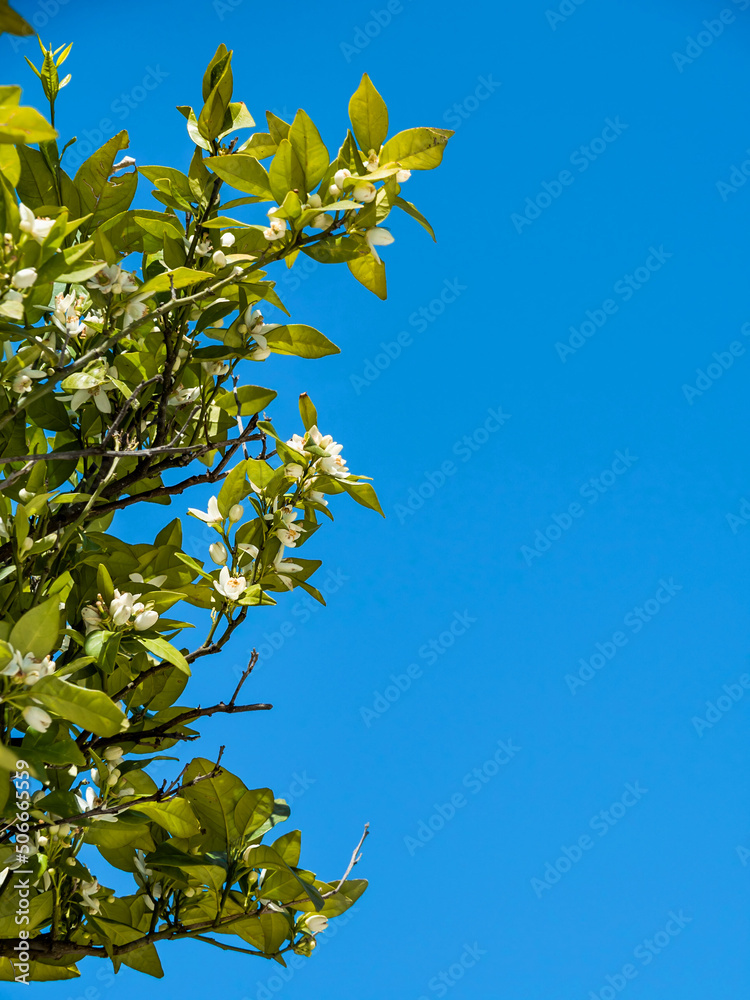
[0, 37, 450, 981]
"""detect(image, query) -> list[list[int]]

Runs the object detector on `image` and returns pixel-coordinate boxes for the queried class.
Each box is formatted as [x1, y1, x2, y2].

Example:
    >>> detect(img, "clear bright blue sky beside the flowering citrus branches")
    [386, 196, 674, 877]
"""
[5, 0, 750, 1000]
